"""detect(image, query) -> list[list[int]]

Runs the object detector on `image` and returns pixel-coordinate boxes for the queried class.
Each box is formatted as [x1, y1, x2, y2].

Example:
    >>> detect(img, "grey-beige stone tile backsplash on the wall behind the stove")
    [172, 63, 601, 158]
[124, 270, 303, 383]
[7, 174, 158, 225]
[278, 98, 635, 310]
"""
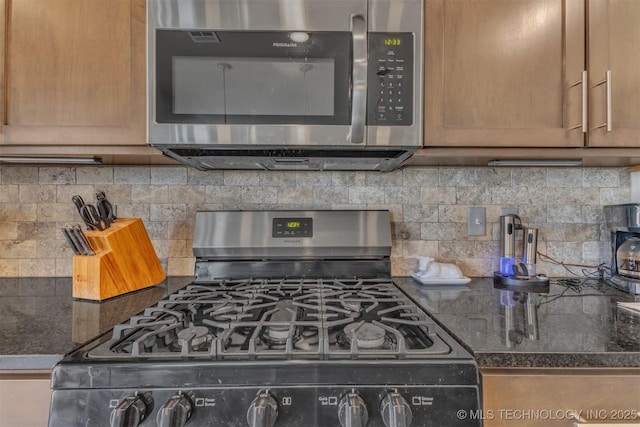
[0, 166, 630, 277]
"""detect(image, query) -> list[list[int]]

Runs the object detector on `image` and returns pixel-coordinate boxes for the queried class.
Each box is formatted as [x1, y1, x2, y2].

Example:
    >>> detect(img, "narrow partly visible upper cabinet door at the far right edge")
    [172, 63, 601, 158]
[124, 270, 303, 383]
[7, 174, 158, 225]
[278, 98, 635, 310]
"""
[588, 0, 640, 147]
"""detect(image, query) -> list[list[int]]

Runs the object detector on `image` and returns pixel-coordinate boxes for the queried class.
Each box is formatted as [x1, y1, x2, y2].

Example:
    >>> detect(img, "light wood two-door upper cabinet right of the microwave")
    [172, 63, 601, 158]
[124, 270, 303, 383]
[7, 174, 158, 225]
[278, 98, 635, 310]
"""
[425, 0, 640, 148]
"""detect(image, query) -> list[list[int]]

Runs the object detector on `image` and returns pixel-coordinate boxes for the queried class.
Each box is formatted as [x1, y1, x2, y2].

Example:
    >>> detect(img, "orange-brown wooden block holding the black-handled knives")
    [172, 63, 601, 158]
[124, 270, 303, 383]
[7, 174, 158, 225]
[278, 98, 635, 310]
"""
[72, 218, 166, 301]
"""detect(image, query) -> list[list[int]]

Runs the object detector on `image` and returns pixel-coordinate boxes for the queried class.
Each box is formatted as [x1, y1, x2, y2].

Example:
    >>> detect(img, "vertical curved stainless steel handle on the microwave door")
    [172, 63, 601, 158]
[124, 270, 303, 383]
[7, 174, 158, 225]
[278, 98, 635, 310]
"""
[348, 15, 367, 144]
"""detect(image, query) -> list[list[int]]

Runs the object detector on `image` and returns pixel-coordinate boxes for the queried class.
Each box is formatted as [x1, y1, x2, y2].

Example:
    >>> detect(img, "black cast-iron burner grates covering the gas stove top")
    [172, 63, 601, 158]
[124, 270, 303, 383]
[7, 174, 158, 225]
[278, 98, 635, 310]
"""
[88, 279, 449, 360]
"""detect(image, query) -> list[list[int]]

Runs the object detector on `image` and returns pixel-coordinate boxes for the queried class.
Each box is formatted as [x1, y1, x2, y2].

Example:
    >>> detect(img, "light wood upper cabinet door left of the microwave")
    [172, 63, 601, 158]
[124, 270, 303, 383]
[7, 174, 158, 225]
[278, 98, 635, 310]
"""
[3, 0, 145, 145]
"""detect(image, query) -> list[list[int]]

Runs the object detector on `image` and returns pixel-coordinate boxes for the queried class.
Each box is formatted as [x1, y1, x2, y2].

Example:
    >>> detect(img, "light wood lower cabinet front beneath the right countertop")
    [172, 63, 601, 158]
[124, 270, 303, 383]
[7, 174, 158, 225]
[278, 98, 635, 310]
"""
[481, 370, 640, 427]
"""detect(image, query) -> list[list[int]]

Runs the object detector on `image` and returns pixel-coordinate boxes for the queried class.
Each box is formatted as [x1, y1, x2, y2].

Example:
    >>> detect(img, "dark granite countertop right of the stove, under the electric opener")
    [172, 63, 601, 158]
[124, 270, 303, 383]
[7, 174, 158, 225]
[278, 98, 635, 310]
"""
[394, 278, 640, 368]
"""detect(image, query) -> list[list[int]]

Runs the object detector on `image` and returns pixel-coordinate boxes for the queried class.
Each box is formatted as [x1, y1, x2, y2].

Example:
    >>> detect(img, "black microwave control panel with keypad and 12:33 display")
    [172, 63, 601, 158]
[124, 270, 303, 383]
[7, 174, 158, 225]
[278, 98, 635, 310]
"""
[367, 33, 414, 126]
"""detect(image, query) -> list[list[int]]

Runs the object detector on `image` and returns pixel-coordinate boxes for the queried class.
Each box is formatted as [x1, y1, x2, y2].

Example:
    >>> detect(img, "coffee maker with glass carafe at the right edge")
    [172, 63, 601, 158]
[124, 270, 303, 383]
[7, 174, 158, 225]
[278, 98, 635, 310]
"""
[604, 203, 640, 294]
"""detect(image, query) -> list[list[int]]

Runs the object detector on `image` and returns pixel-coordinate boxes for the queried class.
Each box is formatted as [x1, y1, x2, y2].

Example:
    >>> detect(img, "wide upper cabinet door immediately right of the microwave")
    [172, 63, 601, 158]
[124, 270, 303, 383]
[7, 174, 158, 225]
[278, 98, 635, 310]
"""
[425, 0, 584, 147]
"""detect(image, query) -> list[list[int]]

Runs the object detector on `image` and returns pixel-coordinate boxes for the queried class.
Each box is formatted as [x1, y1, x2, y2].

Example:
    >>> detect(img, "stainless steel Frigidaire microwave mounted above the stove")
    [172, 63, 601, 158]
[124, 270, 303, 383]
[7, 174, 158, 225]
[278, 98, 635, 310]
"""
[147, 0, 424, 171]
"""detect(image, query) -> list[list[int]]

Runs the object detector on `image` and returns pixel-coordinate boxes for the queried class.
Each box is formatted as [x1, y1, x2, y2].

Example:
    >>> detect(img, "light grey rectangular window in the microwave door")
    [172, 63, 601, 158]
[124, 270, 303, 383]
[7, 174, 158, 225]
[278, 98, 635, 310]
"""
[173, 57, 335, 123]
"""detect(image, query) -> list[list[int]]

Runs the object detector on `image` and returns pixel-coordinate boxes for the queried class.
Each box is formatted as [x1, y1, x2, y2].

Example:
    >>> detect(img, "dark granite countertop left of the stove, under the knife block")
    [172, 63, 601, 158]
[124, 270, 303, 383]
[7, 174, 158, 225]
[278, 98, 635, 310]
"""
[0, 277, 193, 370]
